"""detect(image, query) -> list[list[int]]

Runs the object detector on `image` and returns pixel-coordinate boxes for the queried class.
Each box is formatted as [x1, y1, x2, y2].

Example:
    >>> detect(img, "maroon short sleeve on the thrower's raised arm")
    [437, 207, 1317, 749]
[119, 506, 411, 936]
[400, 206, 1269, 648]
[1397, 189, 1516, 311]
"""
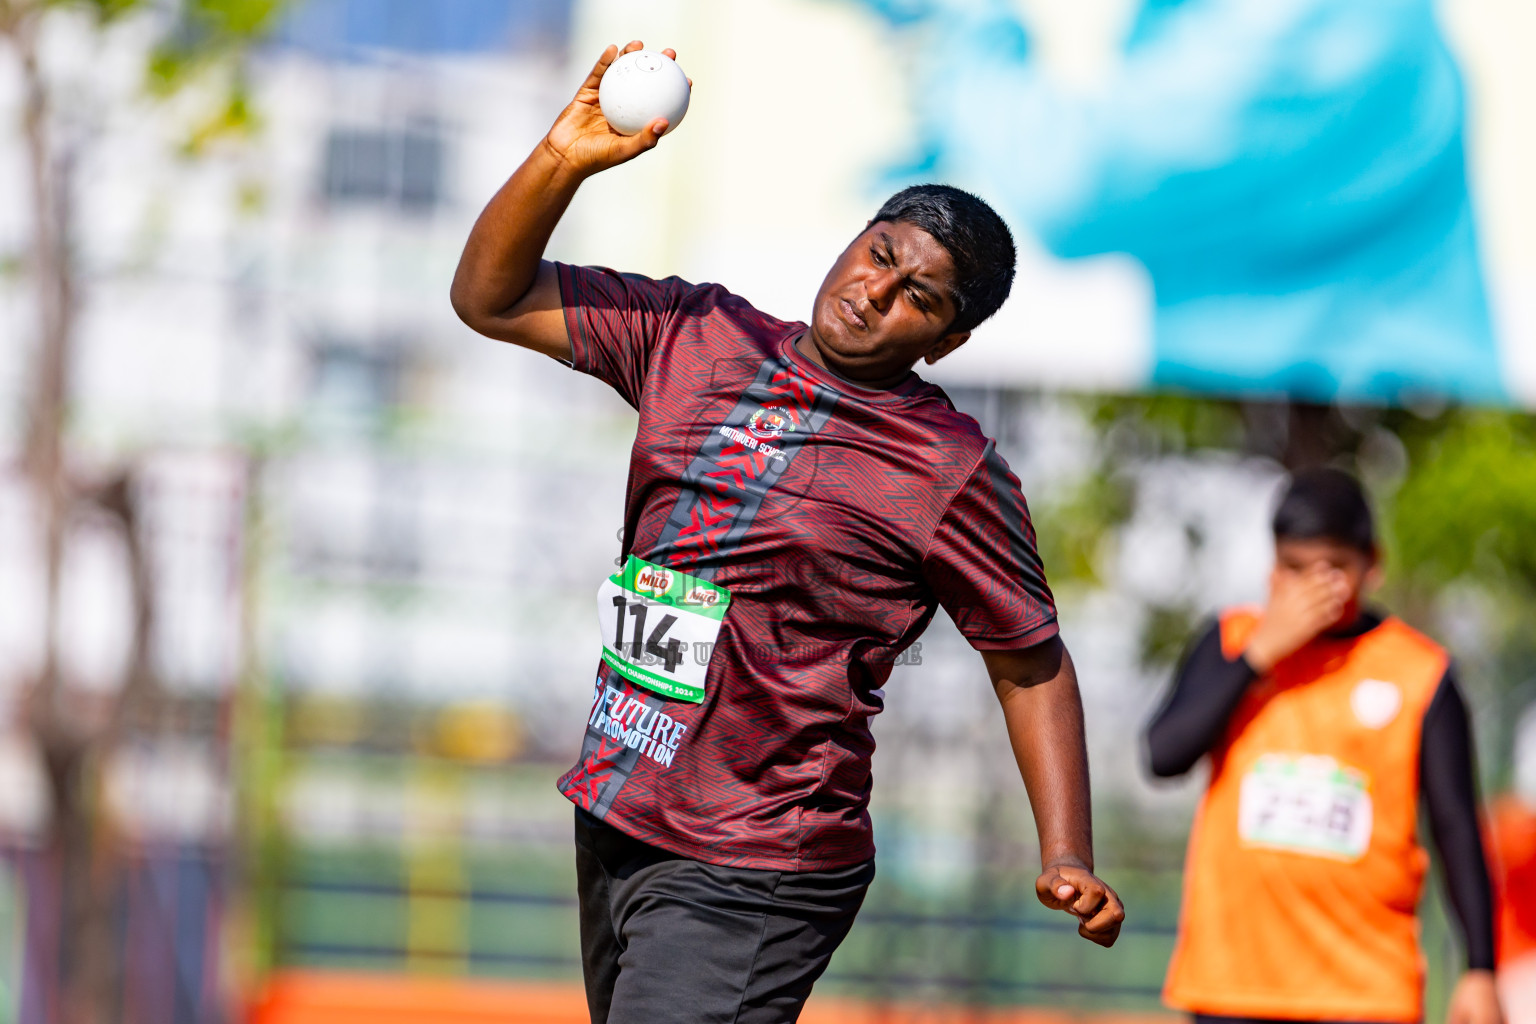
[554, 263, 696, 407]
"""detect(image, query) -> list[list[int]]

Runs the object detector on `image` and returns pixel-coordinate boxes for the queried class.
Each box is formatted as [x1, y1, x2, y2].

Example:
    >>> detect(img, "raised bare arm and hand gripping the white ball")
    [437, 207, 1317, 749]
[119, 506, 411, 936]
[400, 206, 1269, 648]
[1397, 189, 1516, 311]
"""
[449, 40, 676, 361]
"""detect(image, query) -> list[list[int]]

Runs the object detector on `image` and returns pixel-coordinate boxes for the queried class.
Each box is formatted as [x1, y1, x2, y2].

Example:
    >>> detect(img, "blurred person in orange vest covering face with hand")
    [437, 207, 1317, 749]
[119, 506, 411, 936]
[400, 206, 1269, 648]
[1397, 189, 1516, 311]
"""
[1147, 470, 1501, 1024]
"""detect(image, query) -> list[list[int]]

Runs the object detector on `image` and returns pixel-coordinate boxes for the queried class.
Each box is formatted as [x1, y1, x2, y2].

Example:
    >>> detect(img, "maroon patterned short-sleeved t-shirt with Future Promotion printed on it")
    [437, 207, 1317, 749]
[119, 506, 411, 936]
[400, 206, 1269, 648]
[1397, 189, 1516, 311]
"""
[559, 264, 1057, 870]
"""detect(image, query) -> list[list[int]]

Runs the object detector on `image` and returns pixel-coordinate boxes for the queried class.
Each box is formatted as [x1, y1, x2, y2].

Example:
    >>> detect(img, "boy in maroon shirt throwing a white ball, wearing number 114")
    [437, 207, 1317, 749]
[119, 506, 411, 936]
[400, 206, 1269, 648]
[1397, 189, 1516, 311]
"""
[452, 43, 1124, 1024]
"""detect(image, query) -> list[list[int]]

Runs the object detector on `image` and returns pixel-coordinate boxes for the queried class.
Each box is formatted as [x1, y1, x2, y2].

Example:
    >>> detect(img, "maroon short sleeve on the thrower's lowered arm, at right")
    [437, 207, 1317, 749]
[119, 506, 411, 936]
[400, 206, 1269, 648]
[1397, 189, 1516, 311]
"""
[923, 441, 1057, 651]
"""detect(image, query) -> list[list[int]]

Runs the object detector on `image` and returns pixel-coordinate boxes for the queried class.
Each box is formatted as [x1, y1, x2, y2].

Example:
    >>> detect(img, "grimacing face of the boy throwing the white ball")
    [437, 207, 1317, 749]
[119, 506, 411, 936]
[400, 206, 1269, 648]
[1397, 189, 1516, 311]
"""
[800, 221, 971, 387]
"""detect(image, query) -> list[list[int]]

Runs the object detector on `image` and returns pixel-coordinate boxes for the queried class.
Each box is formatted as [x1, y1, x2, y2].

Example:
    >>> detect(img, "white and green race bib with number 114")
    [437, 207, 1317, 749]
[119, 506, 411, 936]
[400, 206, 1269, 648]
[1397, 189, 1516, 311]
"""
[598, 554, 731, 703]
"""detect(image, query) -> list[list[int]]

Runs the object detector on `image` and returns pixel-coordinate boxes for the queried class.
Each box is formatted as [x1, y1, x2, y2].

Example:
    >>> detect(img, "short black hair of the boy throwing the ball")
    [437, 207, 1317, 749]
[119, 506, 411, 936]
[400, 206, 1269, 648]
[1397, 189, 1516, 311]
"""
[871, 184, 1017, 335]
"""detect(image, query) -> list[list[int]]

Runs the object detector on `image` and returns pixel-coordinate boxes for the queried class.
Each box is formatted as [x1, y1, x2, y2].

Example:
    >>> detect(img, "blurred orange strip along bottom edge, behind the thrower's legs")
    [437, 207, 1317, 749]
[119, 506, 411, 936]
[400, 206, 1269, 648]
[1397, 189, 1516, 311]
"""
[247, 970, 1174, 1024]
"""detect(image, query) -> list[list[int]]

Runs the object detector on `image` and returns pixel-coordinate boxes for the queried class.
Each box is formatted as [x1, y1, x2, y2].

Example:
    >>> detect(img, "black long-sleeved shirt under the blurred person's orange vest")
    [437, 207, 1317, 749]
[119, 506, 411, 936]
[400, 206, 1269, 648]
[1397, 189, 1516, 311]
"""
[1146, 613, 1493, 970]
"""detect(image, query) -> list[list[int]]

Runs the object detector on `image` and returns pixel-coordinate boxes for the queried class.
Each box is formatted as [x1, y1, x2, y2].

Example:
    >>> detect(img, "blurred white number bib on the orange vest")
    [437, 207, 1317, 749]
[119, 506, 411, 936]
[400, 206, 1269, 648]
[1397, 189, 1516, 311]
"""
[1238, 754, 1372, 860]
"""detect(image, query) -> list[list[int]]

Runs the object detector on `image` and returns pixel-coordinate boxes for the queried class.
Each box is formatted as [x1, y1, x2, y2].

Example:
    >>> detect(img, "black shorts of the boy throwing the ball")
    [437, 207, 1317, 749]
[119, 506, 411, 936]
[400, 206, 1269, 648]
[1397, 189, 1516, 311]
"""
[576, 808, 874, 1024]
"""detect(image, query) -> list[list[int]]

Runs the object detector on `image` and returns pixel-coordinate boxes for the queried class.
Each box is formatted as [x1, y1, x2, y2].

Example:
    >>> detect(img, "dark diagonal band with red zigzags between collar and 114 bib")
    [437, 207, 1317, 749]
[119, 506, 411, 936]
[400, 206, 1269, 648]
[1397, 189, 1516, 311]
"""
[653, 356, 839, 579]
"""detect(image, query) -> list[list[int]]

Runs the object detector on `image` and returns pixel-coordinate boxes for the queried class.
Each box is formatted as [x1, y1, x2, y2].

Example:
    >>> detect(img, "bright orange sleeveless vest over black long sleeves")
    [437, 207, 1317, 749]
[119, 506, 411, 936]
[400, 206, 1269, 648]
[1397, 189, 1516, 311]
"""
[1163, 609, 1448, 1021]
